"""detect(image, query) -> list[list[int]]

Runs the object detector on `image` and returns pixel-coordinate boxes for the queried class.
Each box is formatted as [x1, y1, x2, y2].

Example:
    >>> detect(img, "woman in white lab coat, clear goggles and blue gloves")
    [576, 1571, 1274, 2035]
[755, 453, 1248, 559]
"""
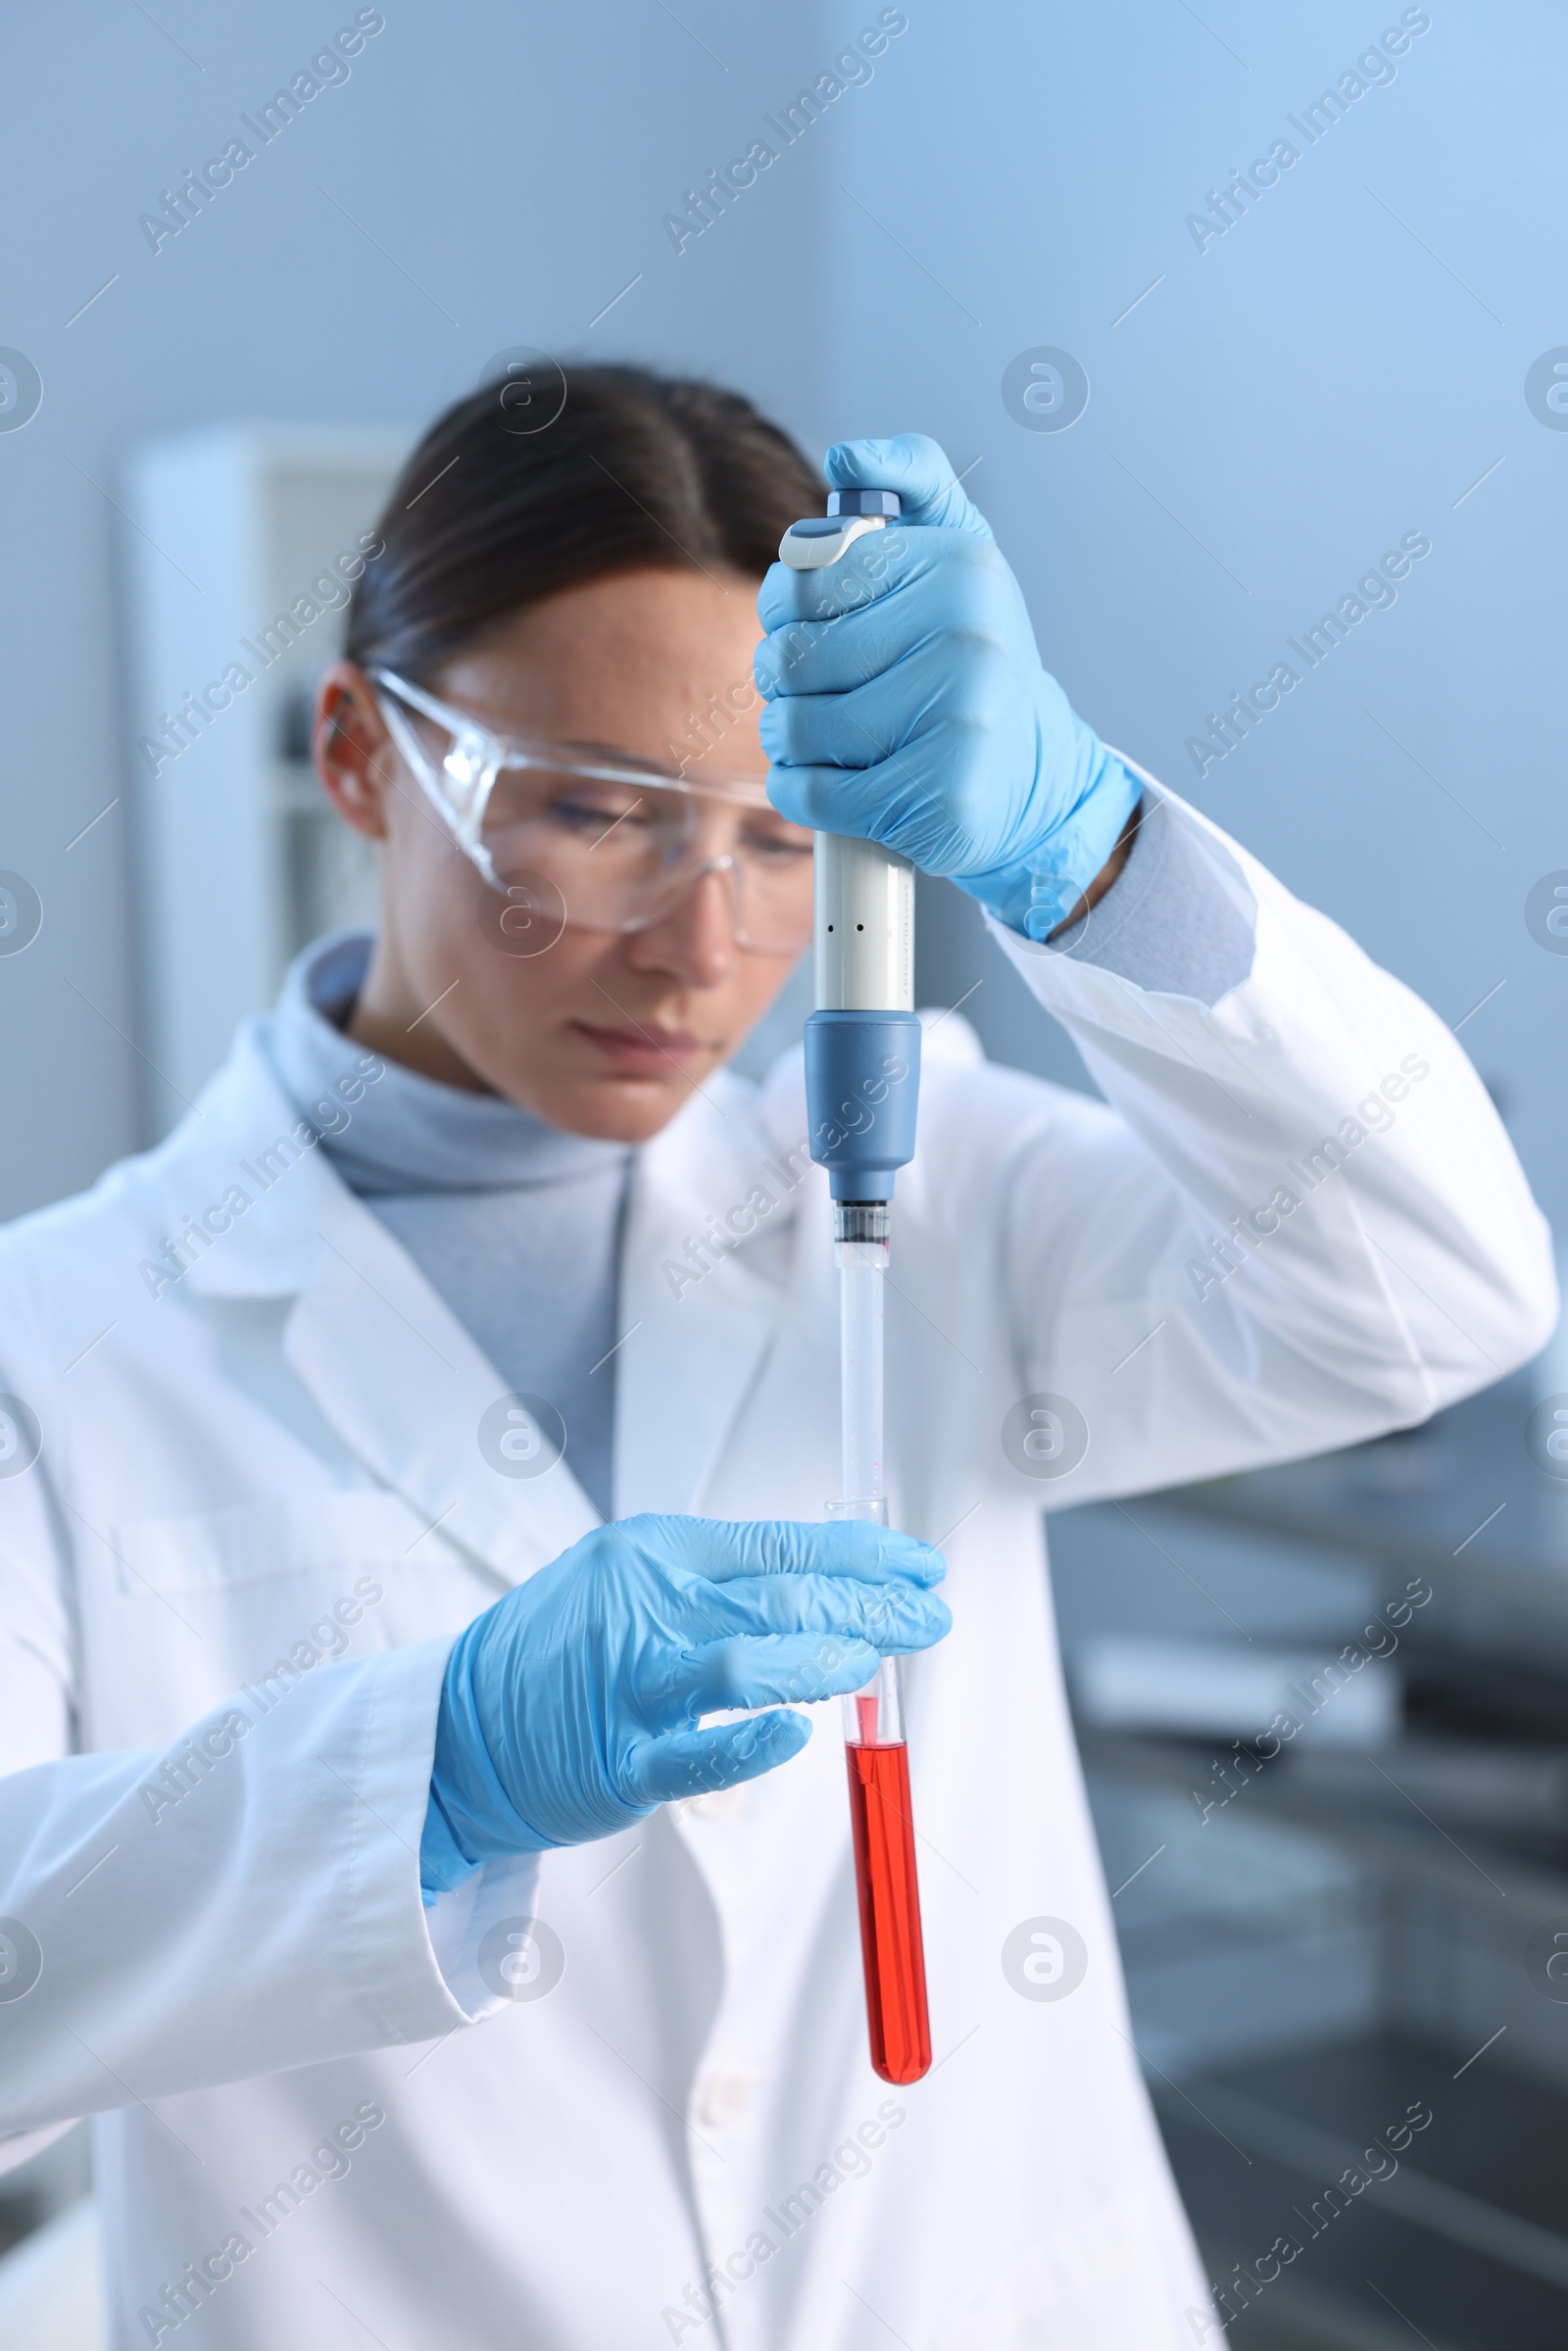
[0, 369, 1551, 2351]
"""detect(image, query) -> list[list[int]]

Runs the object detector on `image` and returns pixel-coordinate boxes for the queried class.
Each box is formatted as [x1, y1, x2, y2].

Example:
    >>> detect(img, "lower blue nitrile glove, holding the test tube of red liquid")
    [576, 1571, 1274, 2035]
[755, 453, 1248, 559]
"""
[418, 1516, 953, 1904]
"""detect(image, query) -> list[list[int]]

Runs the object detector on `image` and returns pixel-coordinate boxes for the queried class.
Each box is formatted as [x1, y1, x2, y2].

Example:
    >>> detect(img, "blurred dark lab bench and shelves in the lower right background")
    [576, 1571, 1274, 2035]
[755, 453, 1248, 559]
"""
[1051, 1375, 1568, 2351]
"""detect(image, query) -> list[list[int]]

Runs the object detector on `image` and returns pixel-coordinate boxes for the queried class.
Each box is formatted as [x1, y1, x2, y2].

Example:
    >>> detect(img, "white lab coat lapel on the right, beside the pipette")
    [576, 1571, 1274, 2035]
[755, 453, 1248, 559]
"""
[615, 1072, 820, 1516]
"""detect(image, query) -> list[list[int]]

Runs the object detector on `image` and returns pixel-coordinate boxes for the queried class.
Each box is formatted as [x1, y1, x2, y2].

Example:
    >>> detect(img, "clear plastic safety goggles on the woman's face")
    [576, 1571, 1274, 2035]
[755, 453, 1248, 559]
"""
[371, 670, 811, 955]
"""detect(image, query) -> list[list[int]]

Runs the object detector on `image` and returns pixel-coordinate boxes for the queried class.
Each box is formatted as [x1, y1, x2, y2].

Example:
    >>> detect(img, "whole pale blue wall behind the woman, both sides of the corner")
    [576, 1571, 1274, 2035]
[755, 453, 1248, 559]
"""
[0, 0, 1568, 1241]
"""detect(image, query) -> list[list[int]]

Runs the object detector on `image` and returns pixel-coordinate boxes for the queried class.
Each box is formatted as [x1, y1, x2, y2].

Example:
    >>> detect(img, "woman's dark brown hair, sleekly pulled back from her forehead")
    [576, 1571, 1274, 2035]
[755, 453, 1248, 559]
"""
[343, 367, 823, 684]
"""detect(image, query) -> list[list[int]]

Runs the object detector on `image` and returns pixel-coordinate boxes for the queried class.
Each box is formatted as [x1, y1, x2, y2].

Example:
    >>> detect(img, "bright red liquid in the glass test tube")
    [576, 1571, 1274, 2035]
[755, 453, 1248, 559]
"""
[844, 1692, 931, 2083]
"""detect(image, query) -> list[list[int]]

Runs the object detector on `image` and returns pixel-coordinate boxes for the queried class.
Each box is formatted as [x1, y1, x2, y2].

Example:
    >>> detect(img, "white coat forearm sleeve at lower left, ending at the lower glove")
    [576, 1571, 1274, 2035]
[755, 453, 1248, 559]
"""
[0, 1639, 472, 2134]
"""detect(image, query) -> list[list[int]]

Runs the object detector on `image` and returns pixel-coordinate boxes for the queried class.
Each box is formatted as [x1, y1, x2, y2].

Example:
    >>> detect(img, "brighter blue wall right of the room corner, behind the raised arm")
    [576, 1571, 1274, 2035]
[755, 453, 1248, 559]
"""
[827, 0, 1568, 1213]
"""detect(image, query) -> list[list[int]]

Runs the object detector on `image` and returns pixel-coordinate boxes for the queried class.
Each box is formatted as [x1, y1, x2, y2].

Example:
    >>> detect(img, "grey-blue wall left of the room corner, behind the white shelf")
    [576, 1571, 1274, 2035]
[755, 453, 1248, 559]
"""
[0, 0, 841, 1215]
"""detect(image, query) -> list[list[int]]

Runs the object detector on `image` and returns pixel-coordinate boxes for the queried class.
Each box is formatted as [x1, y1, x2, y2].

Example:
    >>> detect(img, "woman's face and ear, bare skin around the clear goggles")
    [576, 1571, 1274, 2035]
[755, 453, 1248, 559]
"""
[315, 569, 808, 1143]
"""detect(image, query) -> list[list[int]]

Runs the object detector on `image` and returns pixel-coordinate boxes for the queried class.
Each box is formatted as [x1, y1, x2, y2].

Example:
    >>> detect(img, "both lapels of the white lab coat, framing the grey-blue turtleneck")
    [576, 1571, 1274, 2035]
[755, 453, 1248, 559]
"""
[167, 1030, 808, 1551]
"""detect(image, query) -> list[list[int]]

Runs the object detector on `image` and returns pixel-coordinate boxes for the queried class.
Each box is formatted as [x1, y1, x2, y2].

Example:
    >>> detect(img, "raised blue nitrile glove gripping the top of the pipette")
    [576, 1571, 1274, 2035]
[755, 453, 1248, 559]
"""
[755, 432, 1140, 938]
